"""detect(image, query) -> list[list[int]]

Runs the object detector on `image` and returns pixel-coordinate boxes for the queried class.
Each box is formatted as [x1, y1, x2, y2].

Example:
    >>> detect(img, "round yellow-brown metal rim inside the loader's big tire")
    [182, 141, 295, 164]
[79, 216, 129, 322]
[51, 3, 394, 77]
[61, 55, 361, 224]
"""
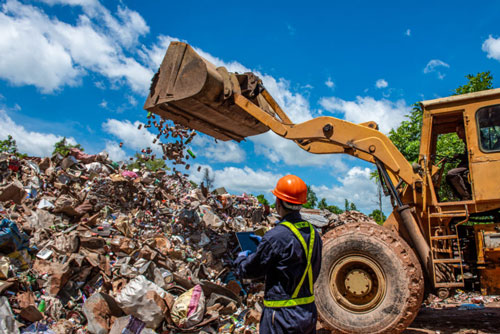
[330, 254, 387, 313]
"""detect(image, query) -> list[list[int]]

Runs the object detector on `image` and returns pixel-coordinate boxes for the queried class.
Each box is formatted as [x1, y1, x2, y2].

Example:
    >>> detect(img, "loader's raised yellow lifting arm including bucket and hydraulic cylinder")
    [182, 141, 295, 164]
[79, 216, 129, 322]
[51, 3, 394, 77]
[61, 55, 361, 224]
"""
[144, 42, 429, 276]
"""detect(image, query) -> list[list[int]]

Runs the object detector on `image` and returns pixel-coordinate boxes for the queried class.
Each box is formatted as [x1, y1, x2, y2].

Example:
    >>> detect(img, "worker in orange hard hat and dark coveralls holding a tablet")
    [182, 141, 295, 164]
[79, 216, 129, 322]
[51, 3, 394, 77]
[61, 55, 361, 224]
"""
[235, 175, 322, 334]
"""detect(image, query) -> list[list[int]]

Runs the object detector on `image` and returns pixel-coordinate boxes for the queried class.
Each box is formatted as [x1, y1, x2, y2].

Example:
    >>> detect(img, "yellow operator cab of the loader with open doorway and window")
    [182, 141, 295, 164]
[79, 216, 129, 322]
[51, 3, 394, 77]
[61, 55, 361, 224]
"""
[420, 89, 500, 212]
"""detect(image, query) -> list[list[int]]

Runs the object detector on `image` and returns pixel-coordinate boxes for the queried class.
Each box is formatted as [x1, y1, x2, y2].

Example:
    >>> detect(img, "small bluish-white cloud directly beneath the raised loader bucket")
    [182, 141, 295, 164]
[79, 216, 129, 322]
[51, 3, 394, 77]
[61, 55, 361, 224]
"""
[192, 134, 245, 163]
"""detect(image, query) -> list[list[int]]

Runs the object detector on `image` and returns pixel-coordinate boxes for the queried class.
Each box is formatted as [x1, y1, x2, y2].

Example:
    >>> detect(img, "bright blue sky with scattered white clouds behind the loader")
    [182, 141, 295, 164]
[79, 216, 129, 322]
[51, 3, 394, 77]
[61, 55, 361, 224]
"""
[0, 0, 500, 212]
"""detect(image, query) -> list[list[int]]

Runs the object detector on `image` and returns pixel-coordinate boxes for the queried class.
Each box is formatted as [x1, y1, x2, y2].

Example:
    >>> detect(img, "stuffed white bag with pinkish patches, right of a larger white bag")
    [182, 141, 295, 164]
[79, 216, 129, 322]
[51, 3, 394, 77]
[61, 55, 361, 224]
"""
[170, 284, 205, 328]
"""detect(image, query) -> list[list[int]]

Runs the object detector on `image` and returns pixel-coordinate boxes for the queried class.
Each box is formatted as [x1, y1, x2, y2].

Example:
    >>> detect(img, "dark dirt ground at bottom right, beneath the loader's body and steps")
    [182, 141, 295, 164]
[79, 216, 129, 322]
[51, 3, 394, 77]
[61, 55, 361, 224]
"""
[403, 302, 500, 334]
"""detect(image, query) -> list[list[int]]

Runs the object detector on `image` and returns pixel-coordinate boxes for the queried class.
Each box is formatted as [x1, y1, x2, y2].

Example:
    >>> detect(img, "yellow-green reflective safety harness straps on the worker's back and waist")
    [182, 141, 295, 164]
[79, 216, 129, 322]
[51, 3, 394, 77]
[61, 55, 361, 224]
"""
[264, 222, 315, 307]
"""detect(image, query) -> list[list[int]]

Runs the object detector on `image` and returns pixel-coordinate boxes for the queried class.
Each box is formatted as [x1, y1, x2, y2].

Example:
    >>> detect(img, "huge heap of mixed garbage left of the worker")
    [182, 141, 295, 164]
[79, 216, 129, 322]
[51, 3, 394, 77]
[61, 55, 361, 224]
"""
[0, 148, 368, 334]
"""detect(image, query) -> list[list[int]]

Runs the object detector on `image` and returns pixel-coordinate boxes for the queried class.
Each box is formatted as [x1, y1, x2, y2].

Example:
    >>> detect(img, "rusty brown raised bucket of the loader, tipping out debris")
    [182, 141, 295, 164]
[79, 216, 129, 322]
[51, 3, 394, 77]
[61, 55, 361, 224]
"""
[144, 42, 274, 141]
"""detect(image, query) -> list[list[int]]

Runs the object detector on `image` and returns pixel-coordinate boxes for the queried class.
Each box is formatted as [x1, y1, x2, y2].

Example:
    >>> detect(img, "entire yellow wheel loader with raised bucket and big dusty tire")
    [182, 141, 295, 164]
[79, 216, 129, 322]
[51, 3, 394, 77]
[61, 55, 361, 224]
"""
[144, 42, 500, 333]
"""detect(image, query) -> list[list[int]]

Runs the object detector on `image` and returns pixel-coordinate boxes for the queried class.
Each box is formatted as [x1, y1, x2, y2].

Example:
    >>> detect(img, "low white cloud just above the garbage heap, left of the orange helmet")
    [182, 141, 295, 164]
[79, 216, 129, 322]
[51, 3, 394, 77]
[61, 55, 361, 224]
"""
[190, 164, 282, 195]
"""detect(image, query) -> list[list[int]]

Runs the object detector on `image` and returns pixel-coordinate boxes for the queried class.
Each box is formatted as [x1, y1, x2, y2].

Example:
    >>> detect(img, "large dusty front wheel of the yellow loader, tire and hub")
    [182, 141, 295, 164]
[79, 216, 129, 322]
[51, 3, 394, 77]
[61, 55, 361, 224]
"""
[315, 223, 424, 334]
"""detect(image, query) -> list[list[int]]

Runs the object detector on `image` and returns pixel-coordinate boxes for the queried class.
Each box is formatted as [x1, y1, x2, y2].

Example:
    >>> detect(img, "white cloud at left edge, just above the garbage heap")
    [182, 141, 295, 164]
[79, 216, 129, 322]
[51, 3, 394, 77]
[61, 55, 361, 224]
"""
[0, 109, 76, 157]
